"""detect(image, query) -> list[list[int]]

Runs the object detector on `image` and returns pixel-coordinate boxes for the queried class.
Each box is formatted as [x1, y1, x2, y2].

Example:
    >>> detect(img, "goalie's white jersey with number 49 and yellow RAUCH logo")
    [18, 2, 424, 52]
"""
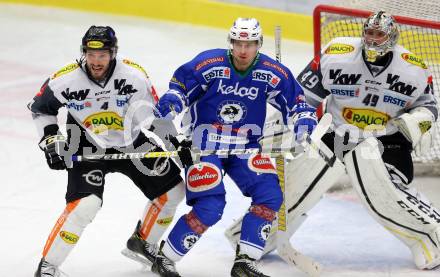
[298, 37, 438, 139]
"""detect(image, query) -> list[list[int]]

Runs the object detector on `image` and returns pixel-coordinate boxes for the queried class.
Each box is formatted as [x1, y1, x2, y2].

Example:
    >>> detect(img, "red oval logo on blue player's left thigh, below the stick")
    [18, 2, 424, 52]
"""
[186, 162, 222, 192]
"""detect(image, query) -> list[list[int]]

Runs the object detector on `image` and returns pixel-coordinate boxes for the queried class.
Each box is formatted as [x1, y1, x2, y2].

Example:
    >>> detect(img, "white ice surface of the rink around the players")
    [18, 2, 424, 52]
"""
[0, 4, 440, 277]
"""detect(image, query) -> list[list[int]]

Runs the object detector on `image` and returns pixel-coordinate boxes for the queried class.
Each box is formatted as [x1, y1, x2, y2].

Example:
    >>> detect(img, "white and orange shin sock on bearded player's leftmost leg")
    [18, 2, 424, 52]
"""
[43, 194, 102, 266]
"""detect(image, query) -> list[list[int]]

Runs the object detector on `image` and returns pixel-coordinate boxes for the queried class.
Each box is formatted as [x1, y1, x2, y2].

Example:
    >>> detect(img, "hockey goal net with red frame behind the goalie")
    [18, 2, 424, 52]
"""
[313, 0, 440, 175]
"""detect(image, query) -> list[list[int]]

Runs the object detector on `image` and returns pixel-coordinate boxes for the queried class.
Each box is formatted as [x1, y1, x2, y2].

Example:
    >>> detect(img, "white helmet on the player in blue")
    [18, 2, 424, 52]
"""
[228, 17, 263, 48]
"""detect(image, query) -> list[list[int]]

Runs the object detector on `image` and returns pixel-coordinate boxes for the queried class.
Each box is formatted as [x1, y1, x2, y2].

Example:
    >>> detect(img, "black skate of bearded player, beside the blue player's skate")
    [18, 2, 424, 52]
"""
[121, 221, 157, 267]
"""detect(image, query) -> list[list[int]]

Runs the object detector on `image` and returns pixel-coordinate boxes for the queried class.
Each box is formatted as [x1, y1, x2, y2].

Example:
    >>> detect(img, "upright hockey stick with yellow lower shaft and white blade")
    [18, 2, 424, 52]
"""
[275, 26, 321, 276]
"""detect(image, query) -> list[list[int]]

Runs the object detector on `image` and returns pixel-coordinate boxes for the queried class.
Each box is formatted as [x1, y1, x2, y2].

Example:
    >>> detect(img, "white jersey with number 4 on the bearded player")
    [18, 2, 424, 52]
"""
[28, 58, 157, 148]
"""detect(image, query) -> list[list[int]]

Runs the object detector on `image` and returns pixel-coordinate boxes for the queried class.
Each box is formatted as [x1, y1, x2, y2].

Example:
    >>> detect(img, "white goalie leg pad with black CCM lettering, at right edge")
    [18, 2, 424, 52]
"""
[344, 138, 440, 269]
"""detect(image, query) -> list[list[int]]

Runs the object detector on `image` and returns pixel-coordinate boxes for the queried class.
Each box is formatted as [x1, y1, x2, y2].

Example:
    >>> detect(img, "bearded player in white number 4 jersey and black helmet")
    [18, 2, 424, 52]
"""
[28, 26, 184, 277]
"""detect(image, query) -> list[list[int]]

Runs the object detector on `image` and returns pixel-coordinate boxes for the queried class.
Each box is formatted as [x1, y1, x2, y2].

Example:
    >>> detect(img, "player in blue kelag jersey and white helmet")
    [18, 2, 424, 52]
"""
[152, 18, 316, 277]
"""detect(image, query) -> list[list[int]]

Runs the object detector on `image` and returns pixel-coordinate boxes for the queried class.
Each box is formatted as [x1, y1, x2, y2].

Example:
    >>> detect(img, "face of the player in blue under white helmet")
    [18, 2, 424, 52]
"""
[232, 40, 258, 70]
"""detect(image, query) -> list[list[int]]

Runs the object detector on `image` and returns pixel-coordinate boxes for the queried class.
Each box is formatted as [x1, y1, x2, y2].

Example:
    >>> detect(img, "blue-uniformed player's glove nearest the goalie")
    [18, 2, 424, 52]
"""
[293, 102, 318, 143]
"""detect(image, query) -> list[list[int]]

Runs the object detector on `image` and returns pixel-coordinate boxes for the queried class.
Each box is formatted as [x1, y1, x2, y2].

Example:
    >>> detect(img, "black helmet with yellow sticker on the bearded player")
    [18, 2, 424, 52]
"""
[81, 25, 118, 58]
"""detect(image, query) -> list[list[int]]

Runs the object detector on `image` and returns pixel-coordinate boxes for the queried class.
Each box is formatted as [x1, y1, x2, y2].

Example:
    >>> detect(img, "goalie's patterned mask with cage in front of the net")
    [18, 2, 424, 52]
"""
[362, 11, 399, 62]
